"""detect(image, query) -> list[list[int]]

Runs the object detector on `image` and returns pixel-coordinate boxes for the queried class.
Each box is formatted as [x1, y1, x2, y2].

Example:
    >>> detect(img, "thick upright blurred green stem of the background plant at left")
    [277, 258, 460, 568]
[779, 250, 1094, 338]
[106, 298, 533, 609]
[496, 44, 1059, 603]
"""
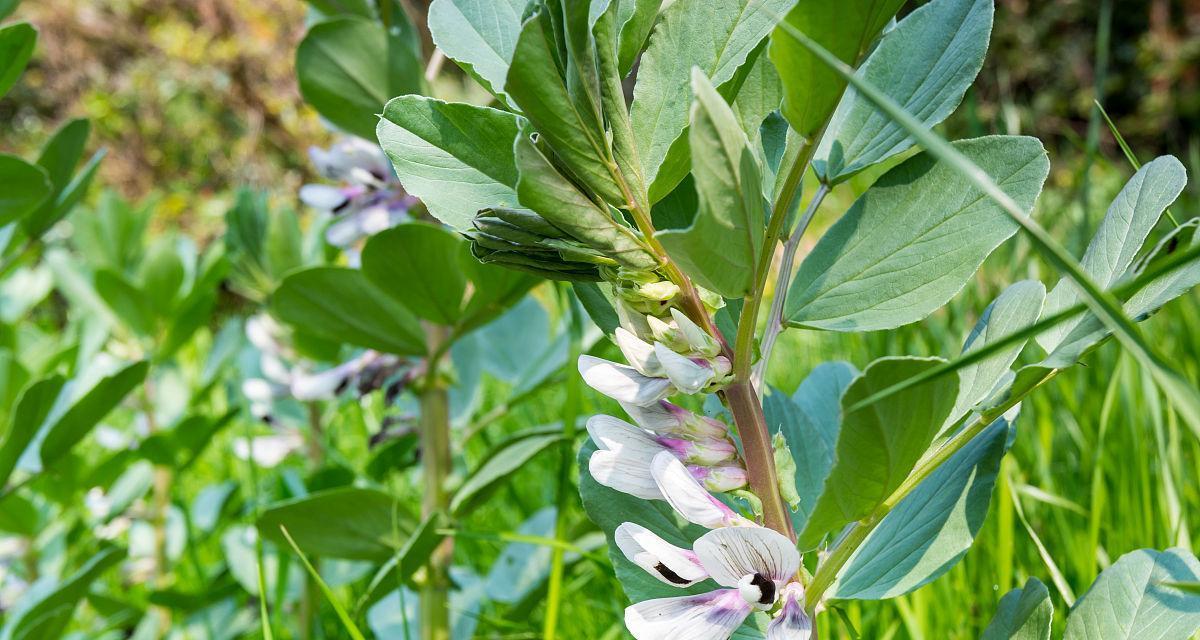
[420, 325, 454, 640]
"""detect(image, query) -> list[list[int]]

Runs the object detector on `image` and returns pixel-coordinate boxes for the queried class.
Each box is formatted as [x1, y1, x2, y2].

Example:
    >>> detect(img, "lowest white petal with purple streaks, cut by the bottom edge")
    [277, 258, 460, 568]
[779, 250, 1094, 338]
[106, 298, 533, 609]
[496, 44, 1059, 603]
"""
[625, 590, 750, 640]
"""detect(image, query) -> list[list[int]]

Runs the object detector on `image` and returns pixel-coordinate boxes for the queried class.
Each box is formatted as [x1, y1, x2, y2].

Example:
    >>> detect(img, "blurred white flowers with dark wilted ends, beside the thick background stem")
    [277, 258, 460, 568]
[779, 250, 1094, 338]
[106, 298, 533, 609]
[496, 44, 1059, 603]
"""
[241, 315, 408, 421]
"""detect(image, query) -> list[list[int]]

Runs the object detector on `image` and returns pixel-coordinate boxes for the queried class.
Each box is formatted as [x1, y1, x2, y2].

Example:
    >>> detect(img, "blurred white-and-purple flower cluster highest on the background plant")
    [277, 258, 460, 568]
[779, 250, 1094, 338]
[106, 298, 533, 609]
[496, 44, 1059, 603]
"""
[300, 137, 416, 264]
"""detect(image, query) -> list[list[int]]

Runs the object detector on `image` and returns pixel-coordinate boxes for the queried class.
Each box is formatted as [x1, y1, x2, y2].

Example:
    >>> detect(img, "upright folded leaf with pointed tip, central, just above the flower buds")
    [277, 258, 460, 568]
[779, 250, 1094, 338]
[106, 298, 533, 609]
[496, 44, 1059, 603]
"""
[656, 70, 767, 298]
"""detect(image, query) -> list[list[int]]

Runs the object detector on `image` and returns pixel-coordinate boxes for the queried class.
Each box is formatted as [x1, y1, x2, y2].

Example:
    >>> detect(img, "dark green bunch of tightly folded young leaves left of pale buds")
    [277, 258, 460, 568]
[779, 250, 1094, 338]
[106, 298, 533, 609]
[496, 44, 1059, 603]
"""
[467, 208, 617, 281]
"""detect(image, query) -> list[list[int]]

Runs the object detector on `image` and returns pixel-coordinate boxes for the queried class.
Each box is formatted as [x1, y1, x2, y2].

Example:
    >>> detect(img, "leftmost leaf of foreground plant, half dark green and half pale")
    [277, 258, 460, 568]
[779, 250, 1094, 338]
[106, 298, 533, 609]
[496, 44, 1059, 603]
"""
[377, 96, 517, 231]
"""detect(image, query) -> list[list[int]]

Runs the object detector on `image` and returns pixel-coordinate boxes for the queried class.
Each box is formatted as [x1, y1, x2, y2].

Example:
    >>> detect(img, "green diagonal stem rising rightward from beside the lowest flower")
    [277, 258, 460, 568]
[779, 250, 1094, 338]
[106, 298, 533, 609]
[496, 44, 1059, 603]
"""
[804, 369, 1061, 612]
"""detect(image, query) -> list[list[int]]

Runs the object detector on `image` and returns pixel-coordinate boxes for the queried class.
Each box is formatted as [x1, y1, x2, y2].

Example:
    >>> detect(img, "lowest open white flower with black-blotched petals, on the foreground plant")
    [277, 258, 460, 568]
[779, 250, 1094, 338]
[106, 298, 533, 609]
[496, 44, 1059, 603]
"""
[622, 525, 800, 640]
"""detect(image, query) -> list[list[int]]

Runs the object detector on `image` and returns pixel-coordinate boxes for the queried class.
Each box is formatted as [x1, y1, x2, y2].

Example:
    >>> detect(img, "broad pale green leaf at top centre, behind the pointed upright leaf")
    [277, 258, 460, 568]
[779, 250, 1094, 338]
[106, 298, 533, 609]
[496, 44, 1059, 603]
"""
[630, 0, 796, 201]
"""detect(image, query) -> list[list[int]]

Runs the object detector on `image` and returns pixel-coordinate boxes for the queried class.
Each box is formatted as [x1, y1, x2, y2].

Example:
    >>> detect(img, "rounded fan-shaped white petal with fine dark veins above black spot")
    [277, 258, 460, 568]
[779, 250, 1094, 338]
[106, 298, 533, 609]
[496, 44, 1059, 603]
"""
[695, 526, 800, 587]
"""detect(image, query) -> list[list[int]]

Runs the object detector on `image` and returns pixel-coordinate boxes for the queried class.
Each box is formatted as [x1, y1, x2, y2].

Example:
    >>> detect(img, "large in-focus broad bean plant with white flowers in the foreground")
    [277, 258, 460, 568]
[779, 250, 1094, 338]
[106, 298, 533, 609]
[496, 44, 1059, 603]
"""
[372, 0, 1200, 640]
